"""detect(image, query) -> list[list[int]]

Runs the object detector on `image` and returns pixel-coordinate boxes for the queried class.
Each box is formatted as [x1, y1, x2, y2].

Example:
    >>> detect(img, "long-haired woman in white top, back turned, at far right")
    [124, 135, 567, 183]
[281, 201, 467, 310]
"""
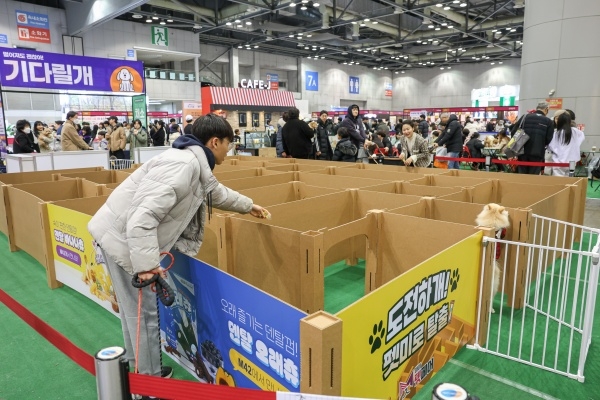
[548, 111, 585, 176]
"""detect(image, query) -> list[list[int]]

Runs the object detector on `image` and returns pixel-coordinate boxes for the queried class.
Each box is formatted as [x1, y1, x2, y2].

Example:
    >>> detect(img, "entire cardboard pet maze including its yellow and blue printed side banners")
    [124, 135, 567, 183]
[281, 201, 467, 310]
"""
[0, 157, 587, 398]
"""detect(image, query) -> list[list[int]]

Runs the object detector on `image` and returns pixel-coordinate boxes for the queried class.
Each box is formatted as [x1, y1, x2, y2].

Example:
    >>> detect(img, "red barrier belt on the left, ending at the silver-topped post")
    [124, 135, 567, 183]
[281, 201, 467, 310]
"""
[0, 289, 96, 375]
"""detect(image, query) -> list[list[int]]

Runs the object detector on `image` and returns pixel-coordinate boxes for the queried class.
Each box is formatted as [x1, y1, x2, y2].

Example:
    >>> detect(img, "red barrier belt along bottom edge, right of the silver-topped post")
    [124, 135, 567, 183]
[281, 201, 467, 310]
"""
[129, 373, 277, 400]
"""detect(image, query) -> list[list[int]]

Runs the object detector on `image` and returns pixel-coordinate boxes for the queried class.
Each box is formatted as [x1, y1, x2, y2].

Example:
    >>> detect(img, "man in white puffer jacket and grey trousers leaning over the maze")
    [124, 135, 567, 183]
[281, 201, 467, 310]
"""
[88, 114, 269, 377]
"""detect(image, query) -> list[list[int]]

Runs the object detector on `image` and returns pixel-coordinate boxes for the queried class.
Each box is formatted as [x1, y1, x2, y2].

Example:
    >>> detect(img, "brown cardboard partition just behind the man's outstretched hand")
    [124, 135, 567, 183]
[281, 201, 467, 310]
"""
[240, 181, 341, 207]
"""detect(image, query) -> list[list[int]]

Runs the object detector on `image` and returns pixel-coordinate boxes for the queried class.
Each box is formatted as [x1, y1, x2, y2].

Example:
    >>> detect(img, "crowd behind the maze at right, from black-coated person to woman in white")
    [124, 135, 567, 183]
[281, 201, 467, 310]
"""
[275, 102, 585, 176]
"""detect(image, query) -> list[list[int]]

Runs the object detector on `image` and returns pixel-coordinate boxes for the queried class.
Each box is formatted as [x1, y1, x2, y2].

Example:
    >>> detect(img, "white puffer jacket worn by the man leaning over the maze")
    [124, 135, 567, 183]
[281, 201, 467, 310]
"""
[88, 146, 252, 274]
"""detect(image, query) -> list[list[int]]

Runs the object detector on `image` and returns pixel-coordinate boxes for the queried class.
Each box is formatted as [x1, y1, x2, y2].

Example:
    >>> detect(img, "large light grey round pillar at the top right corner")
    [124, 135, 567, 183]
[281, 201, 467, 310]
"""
[519, 0, 600, 148]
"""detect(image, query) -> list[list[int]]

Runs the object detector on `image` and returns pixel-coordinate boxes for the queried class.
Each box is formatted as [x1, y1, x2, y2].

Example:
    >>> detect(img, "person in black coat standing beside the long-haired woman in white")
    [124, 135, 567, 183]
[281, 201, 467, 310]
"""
[511, 102, 554, 175]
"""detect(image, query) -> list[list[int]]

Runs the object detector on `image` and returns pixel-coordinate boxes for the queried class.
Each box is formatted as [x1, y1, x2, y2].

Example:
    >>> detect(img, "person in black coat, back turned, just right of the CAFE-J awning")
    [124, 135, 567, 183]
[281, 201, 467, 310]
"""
[281, 108, 315, 158]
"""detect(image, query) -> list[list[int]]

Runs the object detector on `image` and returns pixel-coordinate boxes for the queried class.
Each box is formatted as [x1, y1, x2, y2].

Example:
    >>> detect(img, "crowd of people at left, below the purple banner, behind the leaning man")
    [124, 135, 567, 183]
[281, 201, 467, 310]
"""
[12, 111, 193, 159]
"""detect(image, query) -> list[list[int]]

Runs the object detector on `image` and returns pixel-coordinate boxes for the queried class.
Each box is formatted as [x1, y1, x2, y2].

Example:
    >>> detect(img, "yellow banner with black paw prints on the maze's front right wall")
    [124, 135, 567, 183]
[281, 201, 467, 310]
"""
[337, 232, 482, 400]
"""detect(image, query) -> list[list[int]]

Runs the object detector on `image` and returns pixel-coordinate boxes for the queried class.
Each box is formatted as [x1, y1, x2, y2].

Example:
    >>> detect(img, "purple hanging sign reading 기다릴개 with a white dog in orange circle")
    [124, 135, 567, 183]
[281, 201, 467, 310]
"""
[0, 49, 144, 94]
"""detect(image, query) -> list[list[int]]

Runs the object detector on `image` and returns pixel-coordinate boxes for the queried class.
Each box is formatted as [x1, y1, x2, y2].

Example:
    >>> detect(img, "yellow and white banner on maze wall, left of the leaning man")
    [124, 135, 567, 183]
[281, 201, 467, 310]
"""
[48, 204, 119, 315]
